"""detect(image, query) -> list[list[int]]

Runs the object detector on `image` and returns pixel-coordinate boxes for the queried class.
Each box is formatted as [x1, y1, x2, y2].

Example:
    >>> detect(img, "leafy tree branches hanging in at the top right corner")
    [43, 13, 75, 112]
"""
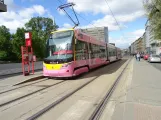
[144, 0, 161, 40]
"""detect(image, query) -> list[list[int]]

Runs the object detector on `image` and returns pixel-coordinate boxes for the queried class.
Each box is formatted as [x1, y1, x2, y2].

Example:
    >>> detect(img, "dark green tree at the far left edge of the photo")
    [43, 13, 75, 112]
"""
[0, 25, 12, 60]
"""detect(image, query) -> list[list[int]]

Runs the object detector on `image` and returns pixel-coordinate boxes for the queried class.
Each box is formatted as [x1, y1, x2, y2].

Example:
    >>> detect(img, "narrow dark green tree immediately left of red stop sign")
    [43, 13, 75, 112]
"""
[12, 28, 26, 60]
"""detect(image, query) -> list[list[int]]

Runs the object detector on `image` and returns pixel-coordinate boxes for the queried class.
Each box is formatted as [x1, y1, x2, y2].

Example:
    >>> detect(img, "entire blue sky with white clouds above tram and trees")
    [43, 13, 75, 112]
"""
[0, 0, 147, 48]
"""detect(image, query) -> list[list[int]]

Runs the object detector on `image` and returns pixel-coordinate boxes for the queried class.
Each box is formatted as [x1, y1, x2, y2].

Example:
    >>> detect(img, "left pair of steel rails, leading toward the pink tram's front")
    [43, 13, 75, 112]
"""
[0, 80, 66, 107]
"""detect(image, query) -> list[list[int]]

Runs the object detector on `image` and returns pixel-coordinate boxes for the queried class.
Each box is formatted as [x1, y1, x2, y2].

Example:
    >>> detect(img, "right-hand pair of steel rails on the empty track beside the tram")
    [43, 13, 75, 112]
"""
[26, 60, 131, 120]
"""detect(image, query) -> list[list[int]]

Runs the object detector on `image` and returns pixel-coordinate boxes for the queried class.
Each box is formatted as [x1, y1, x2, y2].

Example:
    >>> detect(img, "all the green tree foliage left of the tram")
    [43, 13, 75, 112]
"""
[0, 17, 58, 61]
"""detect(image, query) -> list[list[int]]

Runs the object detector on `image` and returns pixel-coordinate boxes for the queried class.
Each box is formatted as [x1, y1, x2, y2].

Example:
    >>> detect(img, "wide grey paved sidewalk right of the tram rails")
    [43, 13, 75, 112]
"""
[100, 58, 161, 120]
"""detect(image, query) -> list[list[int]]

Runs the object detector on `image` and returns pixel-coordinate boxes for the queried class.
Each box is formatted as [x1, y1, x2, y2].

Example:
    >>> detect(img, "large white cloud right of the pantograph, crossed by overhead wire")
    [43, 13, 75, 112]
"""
[67, 0, 145, 31]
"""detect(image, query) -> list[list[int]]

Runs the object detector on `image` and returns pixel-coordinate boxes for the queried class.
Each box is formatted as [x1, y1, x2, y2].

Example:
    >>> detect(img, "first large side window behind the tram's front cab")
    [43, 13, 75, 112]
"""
[75, 40, 88, 60]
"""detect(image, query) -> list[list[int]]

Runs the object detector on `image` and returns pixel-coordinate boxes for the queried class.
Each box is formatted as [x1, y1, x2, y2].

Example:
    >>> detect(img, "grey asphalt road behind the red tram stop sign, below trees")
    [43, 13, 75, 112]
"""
[0, 62, 43, 75]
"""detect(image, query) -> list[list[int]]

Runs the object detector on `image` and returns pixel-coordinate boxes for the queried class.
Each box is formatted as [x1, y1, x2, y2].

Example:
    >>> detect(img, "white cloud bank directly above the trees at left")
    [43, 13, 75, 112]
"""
[0, 3, 52, 33]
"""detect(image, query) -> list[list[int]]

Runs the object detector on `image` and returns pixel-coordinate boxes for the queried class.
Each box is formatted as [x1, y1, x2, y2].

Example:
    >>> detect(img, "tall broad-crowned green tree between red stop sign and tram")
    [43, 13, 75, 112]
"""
[25, 17, 58, 58]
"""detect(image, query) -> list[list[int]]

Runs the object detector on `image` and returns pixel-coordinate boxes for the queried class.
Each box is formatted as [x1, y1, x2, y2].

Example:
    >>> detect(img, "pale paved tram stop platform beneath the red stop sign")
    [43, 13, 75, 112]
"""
[0, 71, 43, 90]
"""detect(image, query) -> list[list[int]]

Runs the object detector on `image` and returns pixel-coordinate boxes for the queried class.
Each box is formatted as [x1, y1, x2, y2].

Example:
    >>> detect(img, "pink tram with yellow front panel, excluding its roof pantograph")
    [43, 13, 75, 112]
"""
[43, 29, 122, 77]
